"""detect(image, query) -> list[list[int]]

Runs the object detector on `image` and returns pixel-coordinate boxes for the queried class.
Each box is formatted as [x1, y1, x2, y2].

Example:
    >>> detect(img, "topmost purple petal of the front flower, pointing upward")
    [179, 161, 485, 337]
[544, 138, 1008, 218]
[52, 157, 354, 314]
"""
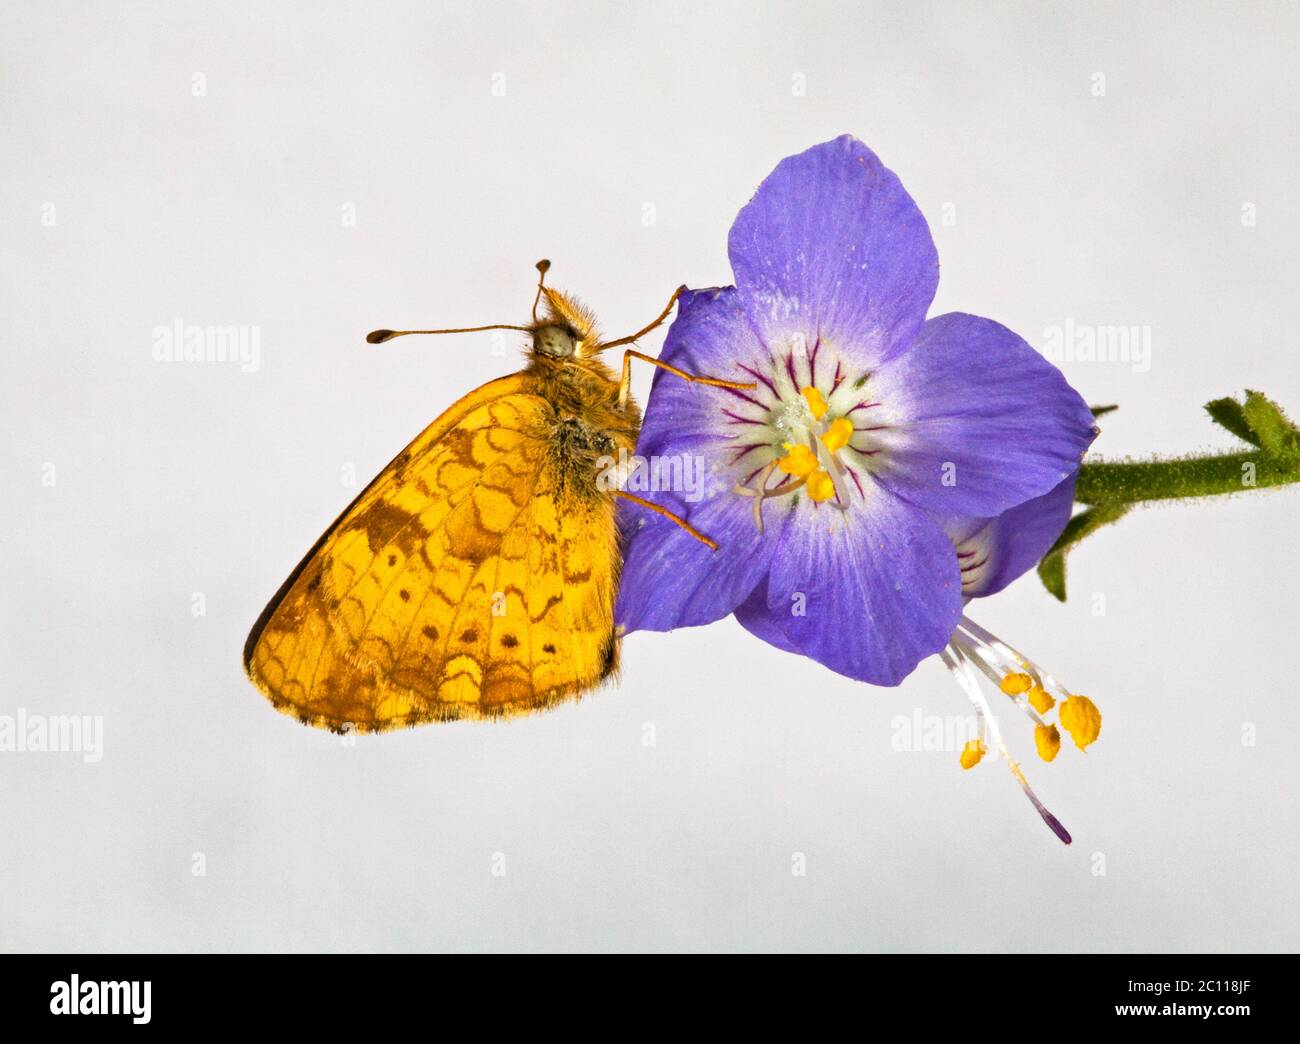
[728, 135, 939, 367]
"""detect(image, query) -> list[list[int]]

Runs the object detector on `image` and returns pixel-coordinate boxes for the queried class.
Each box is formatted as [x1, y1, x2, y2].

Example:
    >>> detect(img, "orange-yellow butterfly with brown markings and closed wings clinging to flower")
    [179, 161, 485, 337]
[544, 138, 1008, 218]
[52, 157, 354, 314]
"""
[243, 260, 753, 732]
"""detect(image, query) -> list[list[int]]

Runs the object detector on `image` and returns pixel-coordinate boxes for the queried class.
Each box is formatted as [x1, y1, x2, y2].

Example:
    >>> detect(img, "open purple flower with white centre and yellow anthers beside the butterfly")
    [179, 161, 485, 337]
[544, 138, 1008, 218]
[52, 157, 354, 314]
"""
[618, 137, 1096, 685]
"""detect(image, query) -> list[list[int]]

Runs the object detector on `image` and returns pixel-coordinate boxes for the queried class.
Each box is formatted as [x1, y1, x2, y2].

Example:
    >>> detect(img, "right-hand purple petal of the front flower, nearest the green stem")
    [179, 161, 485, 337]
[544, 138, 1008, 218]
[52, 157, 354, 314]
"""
[868, 312, 1097, 517]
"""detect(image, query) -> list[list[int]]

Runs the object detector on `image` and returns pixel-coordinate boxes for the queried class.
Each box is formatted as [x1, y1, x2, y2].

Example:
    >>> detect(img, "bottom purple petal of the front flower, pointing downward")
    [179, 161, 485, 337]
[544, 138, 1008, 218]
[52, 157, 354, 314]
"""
[759, 486, 962, 685]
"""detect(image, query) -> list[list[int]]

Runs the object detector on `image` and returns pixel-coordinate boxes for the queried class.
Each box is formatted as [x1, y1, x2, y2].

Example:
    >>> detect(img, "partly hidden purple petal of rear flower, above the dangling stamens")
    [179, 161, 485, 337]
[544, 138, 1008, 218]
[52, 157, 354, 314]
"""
[946, 475, 1078, 598]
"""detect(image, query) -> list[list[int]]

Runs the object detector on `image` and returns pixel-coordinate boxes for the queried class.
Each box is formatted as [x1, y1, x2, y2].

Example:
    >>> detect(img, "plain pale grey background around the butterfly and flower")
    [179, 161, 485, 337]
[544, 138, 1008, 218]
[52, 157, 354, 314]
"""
[0, 3, 1300, 950]
